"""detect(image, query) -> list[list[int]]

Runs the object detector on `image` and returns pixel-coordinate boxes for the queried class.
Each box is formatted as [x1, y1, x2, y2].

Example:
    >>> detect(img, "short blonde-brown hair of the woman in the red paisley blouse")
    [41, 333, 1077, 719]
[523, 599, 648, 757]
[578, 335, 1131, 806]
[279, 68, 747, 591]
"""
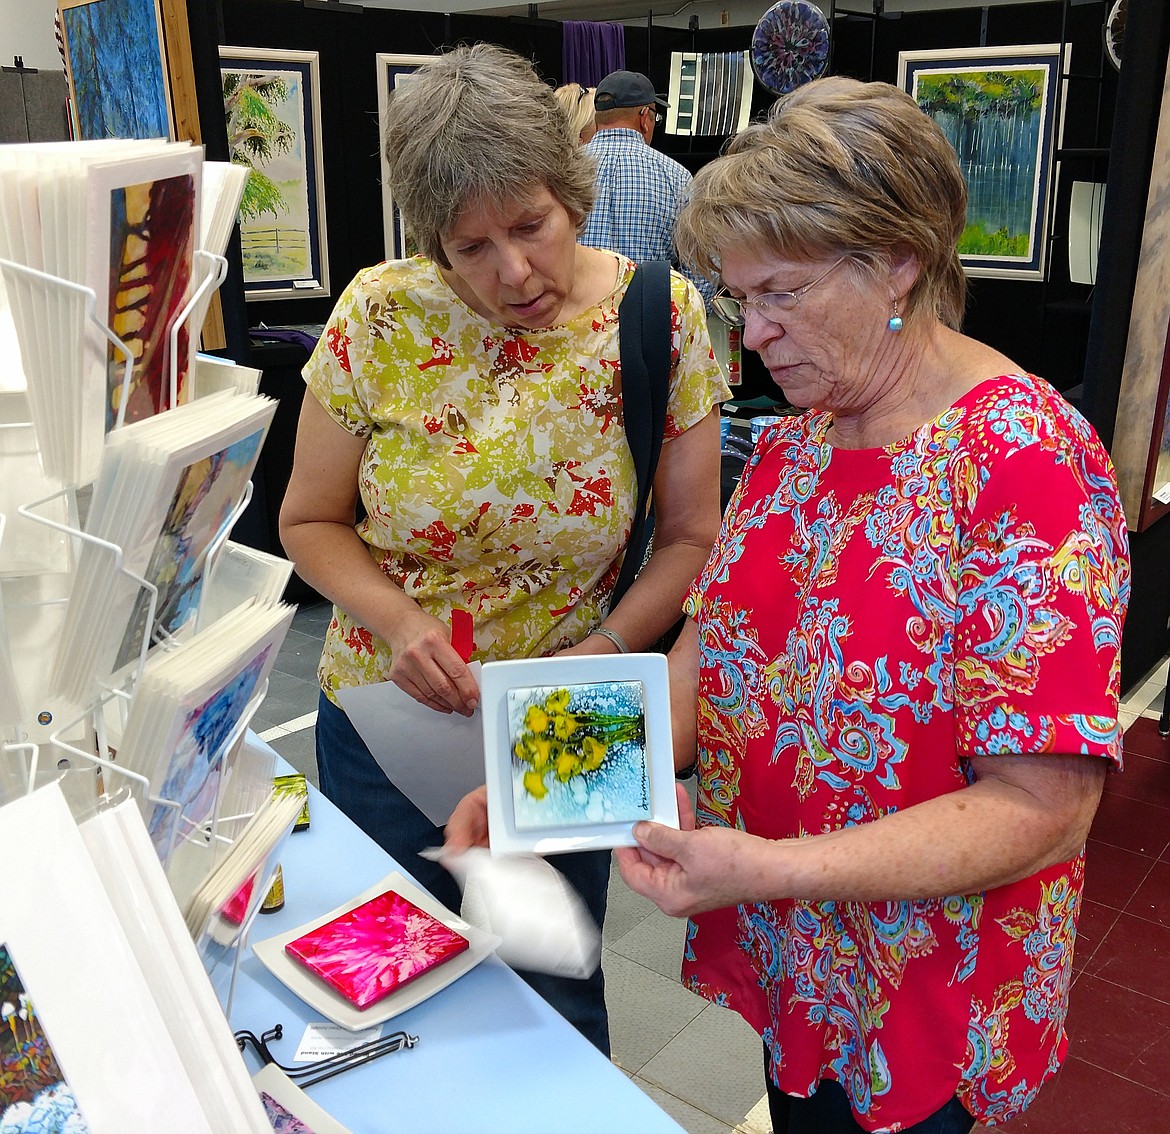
[675, 76, 966, 329]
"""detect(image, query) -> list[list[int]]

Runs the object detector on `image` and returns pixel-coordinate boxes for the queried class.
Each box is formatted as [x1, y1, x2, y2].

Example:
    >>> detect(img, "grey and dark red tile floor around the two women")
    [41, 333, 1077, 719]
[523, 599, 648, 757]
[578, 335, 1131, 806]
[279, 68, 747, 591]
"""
[260, 603, 1170, 1134]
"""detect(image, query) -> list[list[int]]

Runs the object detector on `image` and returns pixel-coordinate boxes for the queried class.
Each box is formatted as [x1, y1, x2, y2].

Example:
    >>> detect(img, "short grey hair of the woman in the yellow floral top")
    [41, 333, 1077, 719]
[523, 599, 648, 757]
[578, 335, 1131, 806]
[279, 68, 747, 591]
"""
[383, 43, 594, 268]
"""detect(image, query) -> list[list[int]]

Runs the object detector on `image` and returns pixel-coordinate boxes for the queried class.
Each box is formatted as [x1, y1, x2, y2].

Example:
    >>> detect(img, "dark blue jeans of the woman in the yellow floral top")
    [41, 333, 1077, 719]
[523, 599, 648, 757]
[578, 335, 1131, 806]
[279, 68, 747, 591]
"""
[317, 693, 610, 1057]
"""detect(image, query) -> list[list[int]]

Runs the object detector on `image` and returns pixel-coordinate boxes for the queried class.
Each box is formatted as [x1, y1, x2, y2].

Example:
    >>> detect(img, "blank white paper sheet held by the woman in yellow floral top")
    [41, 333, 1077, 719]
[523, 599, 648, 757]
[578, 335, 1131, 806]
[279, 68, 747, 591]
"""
[337, 661, 483, 826]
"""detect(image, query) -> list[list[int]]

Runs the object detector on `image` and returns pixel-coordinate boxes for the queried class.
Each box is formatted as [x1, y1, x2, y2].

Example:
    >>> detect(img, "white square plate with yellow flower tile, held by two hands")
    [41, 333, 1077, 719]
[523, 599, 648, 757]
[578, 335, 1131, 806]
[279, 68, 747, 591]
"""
[480, 654, 679, 854]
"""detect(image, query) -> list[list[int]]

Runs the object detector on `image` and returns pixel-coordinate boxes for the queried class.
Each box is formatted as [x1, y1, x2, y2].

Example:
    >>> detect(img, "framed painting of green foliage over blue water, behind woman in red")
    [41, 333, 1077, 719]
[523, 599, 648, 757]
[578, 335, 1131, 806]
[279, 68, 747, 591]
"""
[897, 43, 1068, 280]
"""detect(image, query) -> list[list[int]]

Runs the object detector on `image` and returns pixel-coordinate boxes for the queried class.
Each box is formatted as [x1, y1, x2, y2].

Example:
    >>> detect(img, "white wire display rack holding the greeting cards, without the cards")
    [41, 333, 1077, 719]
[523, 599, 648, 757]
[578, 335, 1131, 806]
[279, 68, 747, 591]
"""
[0, 250, 275, 1011]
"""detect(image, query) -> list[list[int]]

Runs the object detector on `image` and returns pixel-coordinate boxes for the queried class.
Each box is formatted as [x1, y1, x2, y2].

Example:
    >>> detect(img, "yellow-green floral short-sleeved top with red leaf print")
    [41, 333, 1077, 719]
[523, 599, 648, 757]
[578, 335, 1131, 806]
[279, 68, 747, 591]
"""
[304, 256, 730, 700]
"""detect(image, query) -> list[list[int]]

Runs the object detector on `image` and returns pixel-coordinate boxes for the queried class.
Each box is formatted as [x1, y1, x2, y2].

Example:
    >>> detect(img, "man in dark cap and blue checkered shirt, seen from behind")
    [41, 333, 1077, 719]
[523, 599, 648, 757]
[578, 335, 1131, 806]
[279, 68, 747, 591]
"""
[579, 71, 714, 302]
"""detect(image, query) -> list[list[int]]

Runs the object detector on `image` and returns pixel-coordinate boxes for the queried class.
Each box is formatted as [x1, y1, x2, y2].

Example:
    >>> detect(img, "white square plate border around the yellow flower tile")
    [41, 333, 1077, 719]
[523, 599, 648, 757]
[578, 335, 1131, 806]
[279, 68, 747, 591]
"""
[480, 653, 679, 854]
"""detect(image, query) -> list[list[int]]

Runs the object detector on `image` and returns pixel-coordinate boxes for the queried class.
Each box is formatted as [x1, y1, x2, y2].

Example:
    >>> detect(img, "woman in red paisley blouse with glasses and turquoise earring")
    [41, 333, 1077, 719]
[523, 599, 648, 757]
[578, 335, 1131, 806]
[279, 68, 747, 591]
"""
[448, 77, 1129, 1134]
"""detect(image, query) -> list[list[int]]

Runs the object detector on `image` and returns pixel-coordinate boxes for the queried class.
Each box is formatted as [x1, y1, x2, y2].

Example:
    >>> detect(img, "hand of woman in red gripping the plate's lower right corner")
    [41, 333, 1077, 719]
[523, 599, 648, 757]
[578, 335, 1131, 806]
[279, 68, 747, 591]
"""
[613, 784, 775, 917]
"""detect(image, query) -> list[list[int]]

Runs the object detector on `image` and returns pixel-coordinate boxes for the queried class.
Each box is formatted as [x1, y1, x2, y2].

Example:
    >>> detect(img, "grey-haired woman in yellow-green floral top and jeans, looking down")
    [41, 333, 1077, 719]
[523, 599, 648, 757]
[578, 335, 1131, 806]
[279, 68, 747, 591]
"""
[281, 44, 729, 1051]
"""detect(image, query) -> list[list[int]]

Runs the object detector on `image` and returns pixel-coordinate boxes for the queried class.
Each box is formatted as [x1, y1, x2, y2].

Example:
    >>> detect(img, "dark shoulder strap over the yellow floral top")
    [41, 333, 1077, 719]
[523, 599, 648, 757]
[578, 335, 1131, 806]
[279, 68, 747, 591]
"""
[611, 260, 670, 607]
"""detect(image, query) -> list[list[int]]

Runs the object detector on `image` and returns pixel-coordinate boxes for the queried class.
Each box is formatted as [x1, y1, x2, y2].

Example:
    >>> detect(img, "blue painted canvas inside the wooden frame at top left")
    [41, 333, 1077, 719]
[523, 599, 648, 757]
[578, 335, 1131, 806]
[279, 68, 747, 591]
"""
[57, 0, 174, 139]
